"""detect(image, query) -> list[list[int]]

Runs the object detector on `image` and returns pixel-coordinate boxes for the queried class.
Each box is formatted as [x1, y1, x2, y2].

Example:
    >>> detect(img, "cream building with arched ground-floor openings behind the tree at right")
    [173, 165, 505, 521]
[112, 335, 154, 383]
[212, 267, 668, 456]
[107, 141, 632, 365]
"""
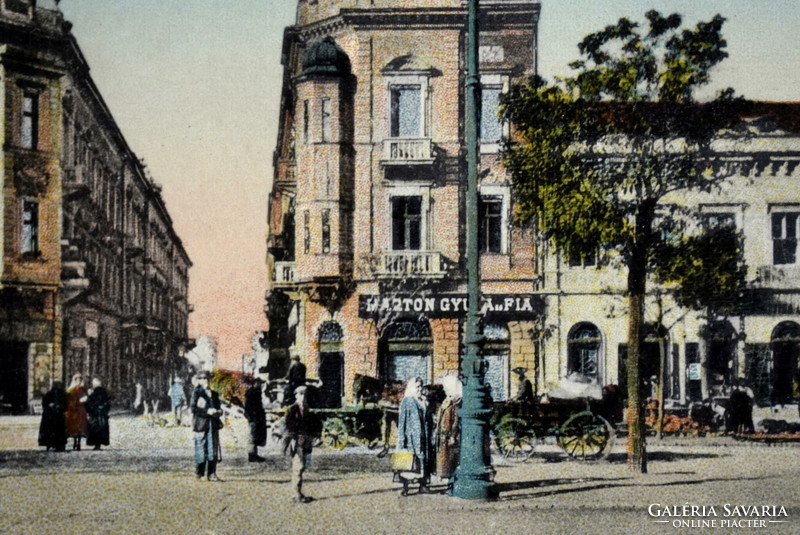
[536, 111, 800, 405]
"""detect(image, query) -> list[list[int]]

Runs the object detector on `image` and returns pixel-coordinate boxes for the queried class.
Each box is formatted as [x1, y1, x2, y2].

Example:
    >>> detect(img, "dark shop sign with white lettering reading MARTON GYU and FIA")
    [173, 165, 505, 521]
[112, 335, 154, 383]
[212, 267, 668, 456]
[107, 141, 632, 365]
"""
[358, 294, 544, 318]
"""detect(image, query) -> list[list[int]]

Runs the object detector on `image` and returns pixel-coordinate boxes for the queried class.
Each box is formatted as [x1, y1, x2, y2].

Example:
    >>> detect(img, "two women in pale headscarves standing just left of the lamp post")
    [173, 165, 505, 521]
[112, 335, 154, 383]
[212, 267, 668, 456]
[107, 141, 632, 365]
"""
[397, 375, 462, 495]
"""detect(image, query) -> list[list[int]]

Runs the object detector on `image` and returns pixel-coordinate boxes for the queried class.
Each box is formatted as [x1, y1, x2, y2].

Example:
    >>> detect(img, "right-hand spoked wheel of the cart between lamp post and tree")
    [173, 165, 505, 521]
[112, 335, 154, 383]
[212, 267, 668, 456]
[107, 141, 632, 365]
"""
[558, 411, 616, 461]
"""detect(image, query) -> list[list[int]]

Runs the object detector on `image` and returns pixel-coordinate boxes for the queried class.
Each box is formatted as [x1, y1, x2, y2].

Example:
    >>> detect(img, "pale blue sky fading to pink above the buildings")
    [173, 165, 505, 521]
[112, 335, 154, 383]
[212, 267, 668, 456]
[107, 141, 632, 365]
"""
[60, 0, 800, 368]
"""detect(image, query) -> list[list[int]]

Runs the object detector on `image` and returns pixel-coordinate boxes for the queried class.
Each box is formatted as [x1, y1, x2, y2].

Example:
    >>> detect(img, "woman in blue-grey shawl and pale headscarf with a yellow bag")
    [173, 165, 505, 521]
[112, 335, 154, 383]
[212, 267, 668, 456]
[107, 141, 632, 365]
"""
[397, 377, 434, 494]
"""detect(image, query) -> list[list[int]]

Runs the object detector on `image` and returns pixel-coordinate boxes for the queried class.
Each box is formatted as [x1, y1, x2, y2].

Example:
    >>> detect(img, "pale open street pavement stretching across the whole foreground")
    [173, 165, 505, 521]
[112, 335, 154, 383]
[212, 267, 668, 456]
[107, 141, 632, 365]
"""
[0, 416, 800, 534]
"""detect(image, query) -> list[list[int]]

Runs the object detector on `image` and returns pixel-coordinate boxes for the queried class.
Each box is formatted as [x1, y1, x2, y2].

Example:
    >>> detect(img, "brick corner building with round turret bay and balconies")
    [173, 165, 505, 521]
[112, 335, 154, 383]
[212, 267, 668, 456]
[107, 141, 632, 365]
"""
[266, 0, 542, 406]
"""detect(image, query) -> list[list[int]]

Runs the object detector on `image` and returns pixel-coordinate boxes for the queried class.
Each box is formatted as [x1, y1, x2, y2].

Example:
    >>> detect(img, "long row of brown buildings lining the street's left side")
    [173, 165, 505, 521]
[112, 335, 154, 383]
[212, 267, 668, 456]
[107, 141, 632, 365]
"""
[0, 0, 191, 411]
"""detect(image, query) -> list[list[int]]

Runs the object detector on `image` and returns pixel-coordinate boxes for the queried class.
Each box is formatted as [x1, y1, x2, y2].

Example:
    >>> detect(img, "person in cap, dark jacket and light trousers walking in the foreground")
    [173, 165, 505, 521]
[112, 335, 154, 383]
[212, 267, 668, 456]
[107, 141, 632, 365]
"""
[283, 386, 322, 503]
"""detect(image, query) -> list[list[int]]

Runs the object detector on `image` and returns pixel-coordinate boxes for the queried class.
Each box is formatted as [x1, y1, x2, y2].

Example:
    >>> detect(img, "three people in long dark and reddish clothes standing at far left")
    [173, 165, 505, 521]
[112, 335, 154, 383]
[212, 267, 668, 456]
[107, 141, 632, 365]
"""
[39, 373, 111, 451]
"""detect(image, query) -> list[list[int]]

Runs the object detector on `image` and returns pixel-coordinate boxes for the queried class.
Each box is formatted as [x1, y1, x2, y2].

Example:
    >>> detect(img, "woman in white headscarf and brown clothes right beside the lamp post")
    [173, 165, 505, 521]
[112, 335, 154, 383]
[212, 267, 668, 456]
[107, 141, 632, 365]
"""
[436, 375, 462, 488]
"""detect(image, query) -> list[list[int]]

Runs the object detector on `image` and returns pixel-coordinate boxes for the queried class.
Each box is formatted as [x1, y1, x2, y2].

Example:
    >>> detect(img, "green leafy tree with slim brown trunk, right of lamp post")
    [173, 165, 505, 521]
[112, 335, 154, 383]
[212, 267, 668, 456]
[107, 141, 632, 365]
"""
[502, 11, 744, 472]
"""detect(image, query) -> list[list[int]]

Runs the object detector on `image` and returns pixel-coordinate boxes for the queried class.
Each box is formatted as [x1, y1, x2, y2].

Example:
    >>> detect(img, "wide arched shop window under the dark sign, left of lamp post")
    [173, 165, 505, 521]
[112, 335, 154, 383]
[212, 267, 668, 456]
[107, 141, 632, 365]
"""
[380, 320, 432, 383]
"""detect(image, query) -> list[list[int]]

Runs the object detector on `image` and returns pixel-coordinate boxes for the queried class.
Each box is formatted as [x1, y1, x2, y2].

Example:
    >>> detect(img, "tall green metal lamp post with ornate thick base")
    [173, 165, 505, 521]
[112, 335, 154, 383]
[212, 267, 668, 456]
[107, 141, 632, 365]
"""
[453, 0, 493, 500]
